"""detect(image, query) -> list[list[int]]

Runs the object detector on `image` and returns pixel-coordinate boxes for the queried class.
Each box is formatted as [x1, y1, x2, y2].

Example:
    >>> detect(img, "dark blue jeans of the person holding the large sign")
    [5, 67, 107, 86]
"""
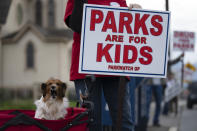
[84, 77, 134, 131]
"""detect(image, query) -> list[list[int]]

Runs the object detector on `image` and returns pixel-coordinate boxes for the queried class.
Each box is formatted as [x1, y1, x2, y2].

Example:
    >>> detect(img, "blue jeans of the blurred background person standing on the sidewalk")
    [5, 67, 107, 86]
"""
[146, 85, 162, 124]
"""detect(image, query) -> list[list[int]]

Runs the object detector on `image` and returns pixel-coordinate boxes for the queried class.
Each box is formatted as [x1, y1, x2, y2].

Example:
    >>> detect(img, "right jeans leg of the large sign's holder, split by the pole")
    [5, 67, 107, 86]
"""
[103, 77, 134, 131]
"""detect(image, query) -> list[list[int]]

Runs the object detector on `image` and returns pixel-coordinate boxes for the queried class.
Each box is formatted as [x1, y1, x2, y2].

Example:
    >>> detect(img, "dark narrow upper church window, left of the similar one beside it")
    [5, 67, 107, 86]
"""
[35, 0, 42, 26]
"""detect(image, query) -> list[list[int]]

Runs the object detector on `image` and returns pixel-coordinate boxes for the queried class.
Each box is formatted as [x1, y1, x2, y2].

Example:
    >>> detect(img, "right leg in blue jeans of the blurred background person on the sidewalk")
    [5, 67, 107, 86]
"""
[153, 86, 162, 125]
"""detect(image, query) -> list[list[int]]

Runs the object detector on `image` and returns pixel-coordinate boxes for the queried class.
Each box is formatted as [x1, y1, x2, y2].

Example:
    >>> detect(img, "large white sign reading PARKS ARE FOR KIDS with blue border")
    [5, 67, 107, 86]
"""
[79, 4, 170, 78]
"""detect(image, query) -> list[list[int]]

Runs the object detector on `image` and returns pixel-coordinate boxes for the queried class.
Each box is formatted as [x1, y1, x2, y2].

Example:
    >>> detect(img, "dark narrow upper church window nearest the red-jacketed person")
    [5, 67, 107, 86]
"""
[48, 0, 55, 27]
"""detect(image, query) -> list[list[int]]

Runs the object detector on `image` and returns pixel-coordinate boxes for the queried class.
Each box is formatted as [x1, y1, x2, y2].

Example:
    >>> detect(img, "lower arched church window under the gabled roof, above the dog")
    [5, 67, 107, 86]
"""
[26, 42, 35, 69]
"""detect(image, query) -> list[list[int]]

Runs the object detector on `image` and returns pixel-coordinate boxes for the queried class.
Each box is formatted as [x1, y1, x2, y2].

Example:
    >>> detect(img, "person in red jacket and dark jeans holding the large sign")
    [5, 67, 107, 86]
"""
[64, 0, 141, 131]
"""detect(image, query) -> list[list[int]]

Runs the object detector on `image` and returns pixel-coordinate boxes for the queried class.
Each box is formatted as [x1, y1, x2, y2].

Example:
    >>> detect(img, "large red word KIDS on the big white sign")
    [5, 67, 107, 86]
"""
[96, 43, 153, 65]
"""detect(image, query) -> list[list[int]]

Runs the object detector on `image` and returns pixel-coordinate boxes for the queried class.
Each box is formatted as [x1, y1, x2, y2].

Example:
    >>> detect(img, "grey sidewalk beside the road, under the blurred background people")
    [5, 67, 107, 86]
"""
[148, 100, 185, 131]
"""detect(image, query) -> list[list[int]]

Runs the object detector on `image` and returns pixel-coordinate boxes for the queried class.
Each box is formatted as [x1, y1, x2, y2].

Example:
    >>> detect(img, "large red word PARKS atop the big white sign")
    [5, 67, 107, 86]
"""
[90, 9, 163, 36]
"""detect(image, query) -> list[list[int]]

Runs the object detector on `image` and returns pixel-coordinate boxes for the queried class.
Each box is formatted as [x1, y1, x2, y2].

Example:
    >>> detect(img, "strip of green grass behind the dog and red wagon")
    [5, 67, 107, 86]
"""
[0, 99, 76, 110]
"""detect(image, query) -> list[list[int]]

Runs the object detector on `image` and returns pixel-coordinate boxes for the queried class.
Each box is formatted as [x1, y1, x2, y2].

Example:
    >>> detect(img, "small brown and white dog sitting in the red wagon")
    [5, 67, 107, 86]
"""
[35, 78, 68, 120]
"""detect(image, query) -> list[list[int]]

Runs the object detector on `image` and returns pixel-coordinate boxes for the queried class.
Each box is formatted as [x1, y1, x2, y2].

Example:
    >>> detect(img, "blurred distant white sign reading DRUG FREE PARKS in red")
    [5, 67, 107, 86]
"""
[173, 31, 195, 51]
